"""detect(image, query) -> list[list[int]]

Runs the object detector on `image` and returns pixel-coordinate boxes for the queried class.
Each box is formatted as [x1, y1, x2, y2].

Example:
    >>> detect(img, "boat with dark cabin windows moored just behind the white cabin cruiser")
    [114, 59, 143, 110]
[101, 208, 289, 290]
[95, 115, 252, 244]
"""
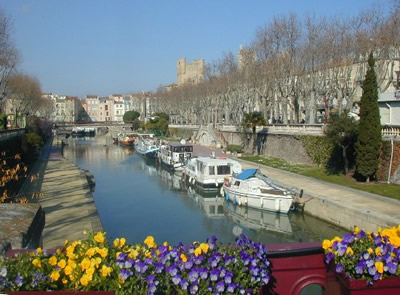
[158, 141, 193, 171]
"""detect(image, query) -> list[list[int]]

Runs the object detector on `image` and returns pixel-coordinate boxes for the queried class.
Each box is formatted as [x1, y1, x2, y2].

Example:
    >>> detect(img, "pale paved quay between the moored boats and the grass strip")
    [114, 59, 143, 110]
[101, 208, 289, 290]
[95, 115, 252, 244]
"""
[194, 145, 400, 235]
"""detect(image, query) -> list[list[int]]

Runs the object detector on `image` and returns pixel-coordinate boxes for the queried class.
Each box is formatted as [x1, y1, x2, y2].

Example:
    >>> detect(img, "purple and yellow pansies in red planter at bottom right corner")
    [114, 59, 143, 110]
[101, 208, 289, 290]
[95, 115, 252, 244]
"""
[322, 225, 400, 294]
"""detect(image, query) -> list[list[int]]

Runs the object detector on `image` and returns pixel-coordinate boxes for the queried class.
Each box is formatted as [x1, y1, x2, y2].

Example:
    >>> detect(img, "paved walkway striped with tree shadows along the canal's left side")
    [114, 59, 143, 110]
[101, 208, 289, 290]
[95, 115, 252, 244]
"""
[20, 138, 103, 249]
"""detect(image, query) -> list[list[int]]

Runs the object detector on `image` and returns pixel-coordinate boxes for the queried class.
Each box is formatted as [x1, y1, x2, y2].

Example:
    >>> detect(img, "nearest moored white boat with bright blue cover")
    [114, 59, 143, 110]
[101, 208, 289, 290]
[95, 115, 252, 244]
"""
[223, 169, 302, 213]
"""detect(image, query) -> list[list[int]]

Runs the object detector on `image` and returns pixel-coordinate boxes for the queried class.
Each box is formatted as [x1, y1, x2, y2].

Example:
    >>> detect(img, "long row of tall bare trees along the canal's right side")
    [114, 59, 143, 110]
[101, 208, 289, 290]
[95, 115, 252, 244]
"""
[151, 1, 400, 128]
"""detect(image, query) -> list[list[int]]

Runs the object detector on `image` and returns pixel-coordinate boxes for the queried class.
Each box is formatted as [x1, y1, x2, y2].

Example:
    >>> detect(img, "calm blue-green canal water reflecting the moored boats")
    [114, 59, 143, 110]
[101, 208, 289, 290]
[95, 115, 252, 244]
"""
[64, 135, 346, 245]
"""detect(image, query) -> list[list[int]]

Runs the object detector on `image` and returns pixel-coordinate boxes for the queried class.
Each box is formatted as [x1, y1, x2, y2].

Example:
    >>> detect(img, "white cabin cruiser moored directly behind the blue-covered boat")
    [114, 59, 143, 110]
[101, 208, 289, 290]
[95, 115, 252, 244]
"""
[183, 157, 242, 190]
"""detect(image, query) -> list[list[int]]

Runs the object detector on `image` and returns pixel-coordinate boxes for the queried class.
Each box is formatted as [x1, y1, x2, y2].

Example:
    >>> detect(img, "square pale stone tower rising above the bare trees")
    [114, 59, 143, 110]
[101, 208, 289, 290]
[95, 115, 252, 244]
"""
[176, 58, 205, 86]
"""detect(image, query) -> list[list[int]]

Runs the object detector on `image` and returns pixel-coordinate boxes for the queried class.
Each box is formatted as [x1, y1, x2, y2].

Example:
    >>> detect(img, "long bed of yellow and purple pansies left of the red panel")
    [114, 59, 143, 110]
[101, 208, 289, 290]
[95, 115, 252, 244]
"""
[0, 232, 270, 294]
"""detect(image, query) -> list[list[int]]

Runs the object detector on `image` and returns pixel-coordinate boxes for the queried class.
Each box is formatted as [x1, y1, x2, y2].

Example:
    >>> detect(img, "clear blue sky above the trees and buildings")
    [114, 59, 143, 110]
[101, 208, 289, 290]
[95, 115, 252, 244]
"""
[0, 0, 390, 98]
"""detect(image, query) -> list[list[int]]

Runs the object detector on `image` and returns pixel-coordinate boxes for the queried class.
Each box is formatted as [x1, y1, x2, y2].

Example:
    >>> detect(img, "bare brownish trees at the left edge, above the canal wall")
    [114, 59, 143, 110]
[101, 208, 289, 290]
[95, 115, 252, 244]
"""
[0, 10, 54, 128]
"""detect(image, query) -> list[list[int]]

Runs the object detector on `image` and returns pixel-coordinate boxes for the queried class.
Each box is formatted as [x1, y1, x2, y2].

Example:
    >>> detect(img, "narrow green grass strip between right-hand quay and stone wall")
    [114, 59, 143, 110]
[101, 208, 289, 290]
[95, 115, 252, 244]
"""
[242, 155, 400, 200]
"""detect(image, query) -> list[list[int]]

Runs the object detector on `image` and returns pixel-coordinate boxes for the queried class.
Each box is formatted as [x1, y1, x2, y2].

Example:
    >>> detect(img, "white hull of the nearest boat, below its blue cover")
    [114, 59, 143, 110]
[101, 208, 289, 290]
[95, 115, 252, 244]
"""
[223, 185, 293, 214]
